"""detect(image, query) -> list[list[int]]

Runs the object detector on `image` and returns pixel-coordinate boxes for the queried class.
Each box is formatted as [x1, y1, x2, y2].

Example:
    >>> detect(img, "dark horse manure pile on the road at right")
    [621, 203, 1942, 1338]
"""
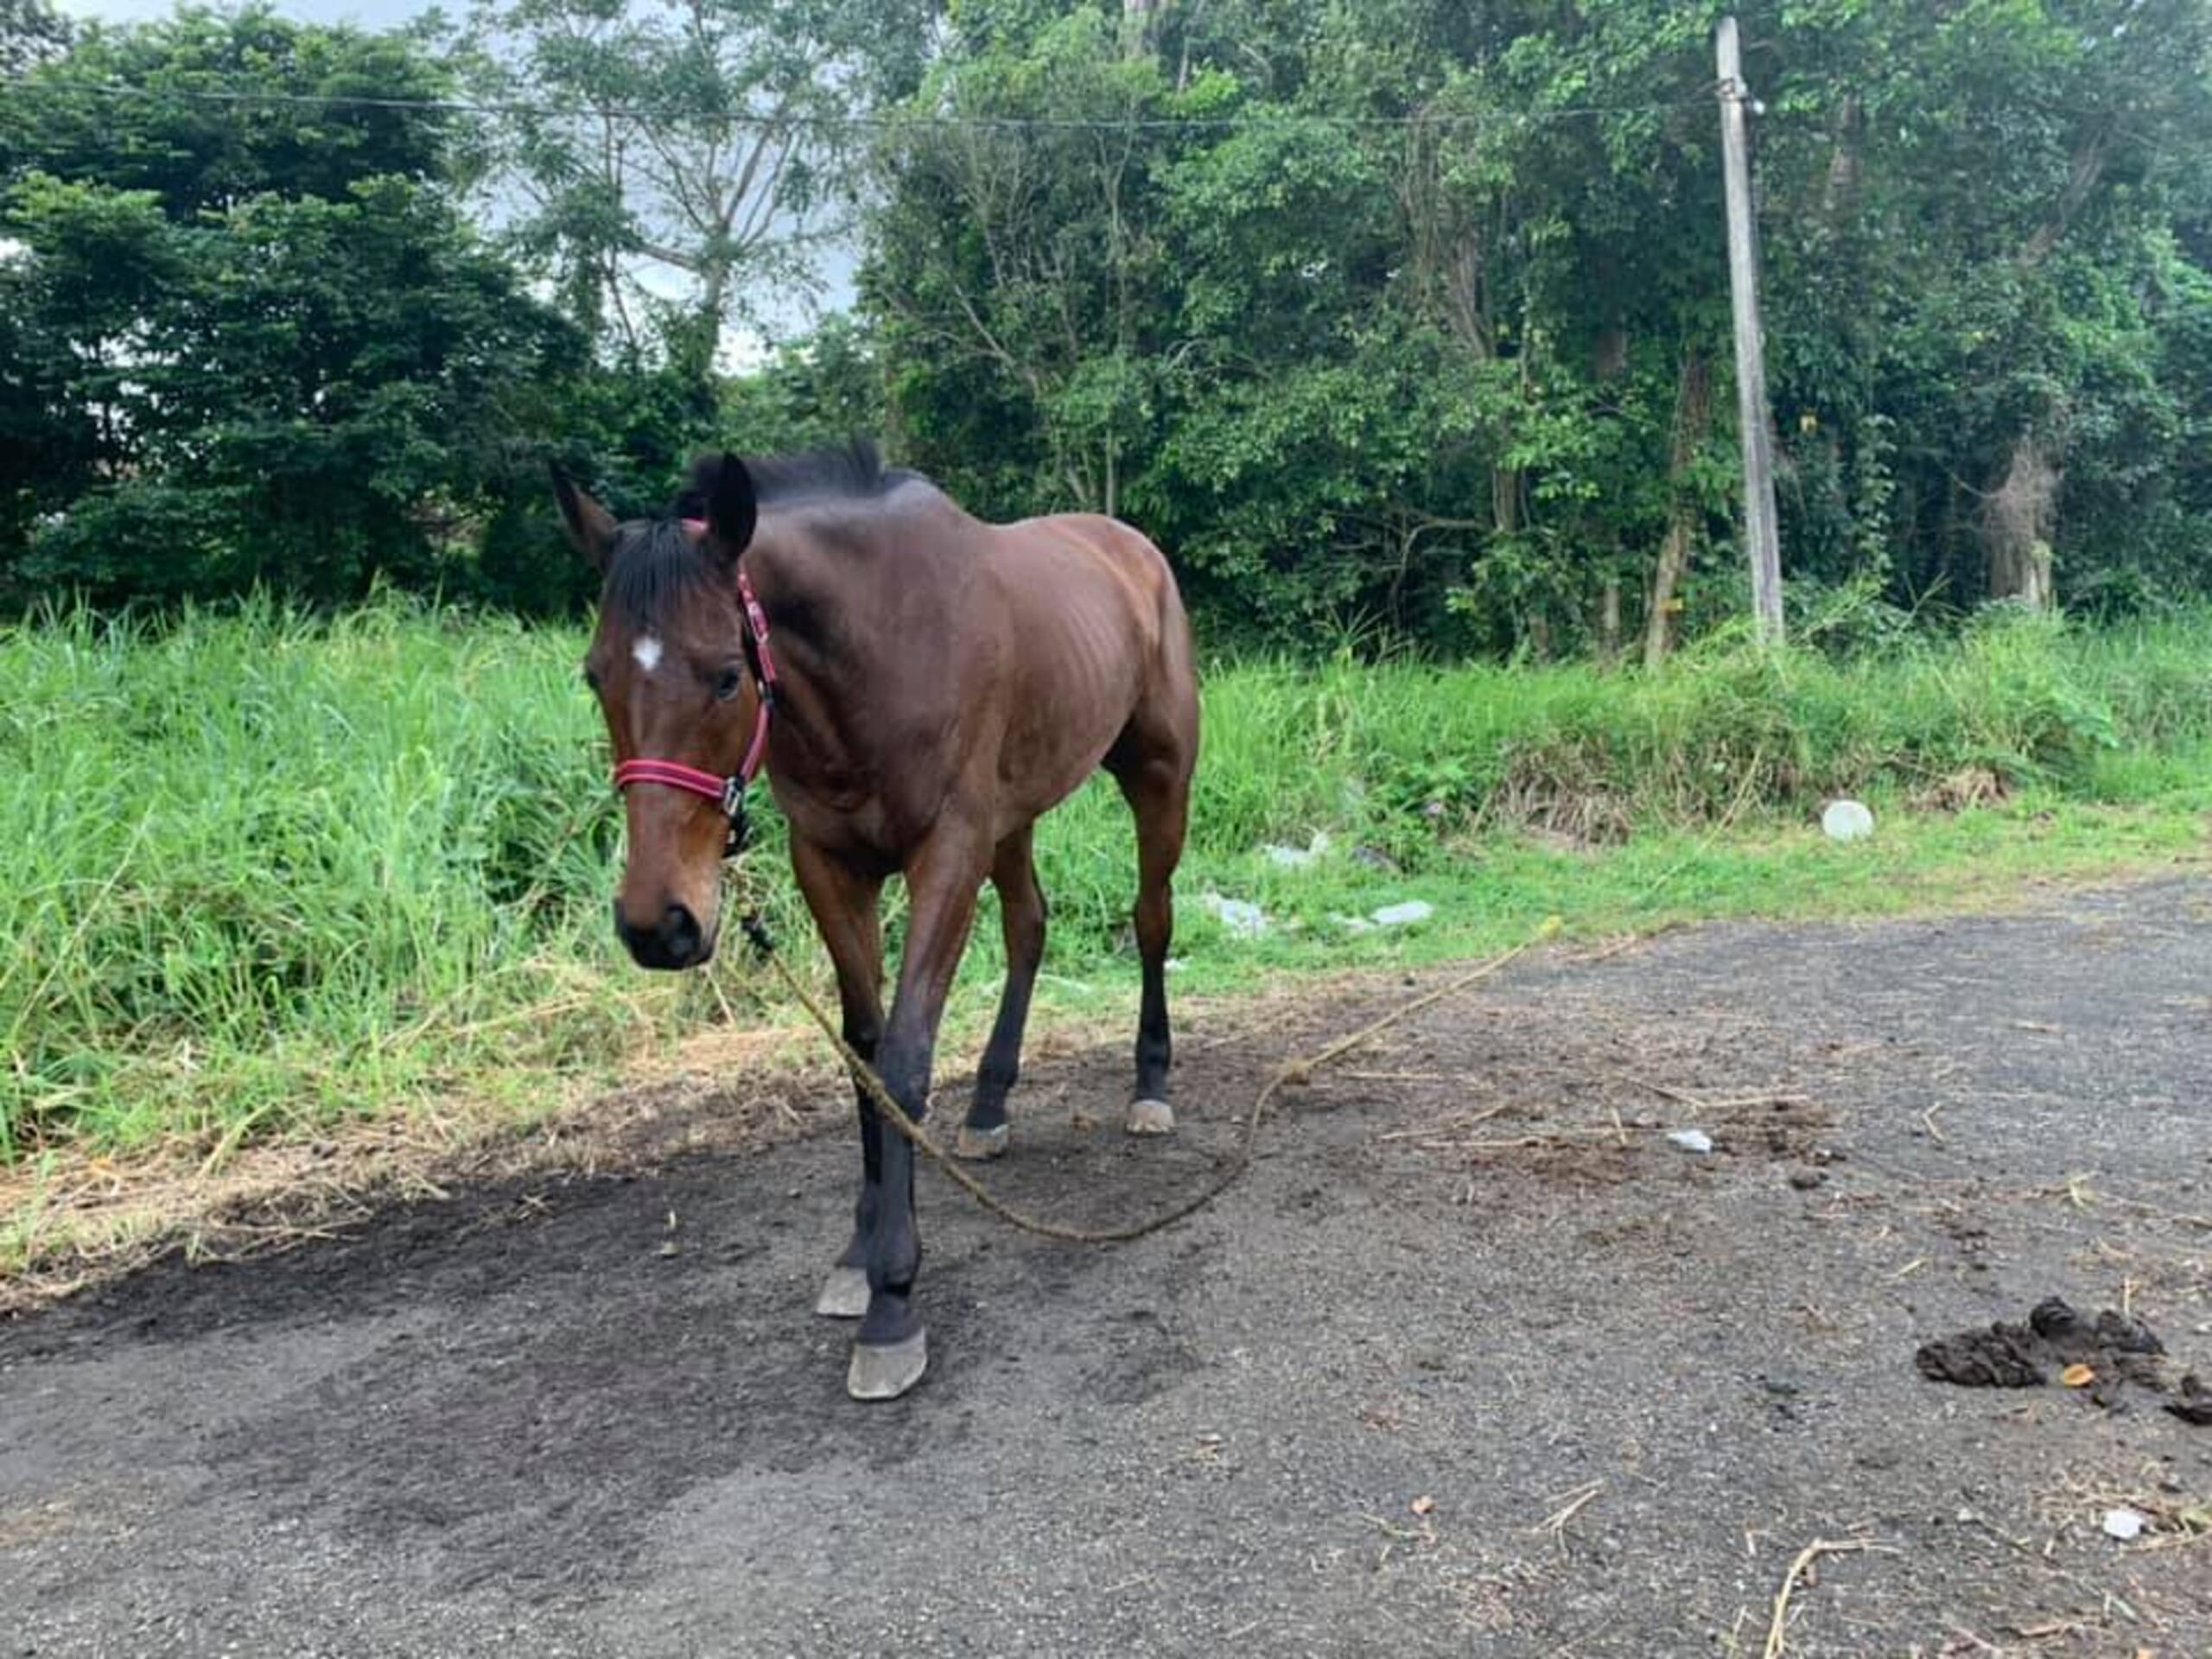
[1913, 1296, 2212, 1427]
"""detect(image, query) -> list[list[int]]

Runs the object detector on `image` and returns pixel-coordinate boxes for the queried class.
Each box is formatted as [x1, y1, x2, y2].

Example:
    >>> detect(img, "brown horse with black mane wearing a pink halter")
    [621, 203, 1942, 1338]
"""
[553, 445, 1199, 1400]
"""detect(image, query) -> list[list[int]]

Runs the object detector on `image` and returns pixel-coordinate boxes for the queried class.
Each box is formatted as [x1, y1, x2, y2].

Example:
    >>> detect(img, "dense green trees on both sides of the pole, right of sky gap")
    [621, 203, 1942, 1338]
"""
[862, 0, 2212, 661]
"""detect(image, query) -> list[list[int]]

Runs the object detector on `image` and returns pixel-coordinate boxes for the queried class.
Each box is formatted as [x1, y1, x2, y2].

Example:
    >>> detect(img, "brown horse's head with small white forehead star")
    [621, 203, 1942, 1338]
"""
[553, 455, 761, 969]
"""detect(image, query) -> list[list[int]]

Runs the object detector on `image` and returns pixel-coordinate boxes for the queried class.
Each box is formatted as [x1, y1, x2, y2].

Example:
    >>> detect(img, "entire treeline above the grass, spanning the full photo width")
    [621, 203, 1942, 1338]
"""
[0, 0, 2212, 657]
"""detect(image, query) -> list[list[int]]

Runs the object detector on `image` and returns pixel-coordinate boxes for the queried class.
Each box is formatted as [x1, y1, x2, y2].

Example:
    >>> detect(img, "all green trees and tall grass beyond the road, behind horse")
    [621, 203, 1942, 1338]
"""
[0, 0, 2212, 1185]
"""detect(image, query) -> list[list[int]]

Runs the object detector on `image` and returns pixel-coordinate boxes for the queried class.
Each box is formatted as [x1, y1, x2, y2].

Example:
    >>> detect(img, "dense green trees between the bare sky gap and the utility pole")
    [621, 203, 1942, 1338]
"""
[865, 0, 1726, 641]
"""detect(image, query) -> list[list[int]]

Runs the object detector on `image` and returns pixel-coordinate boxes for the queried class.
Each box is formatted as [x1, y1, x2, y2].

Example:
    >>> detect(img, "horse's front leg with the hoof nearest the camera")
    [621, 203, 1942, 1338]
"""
[845, 823, 991, 1400]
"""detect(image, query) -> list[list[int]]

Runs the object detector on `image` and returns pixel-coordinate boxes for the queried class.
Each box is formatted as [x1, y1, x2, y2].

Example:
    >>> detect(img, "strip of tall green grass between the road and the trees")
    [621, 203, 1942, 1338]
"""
[0, 601, 2212, 1161]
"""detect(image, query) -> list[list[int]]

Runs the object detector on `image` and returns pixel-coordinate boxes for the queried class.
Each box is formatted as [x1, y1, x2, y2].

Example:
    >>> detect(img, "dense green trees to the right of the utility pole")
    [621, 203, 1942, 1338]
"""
[1754, 0, 2212, 619]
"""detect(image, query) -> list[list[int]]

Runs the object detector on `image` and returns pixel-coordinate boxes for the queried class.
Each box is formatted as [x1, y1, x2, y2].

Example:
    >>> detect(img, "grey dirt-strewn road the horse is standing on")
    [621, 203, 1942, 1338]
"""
[0, 882, 2212, 1659]
